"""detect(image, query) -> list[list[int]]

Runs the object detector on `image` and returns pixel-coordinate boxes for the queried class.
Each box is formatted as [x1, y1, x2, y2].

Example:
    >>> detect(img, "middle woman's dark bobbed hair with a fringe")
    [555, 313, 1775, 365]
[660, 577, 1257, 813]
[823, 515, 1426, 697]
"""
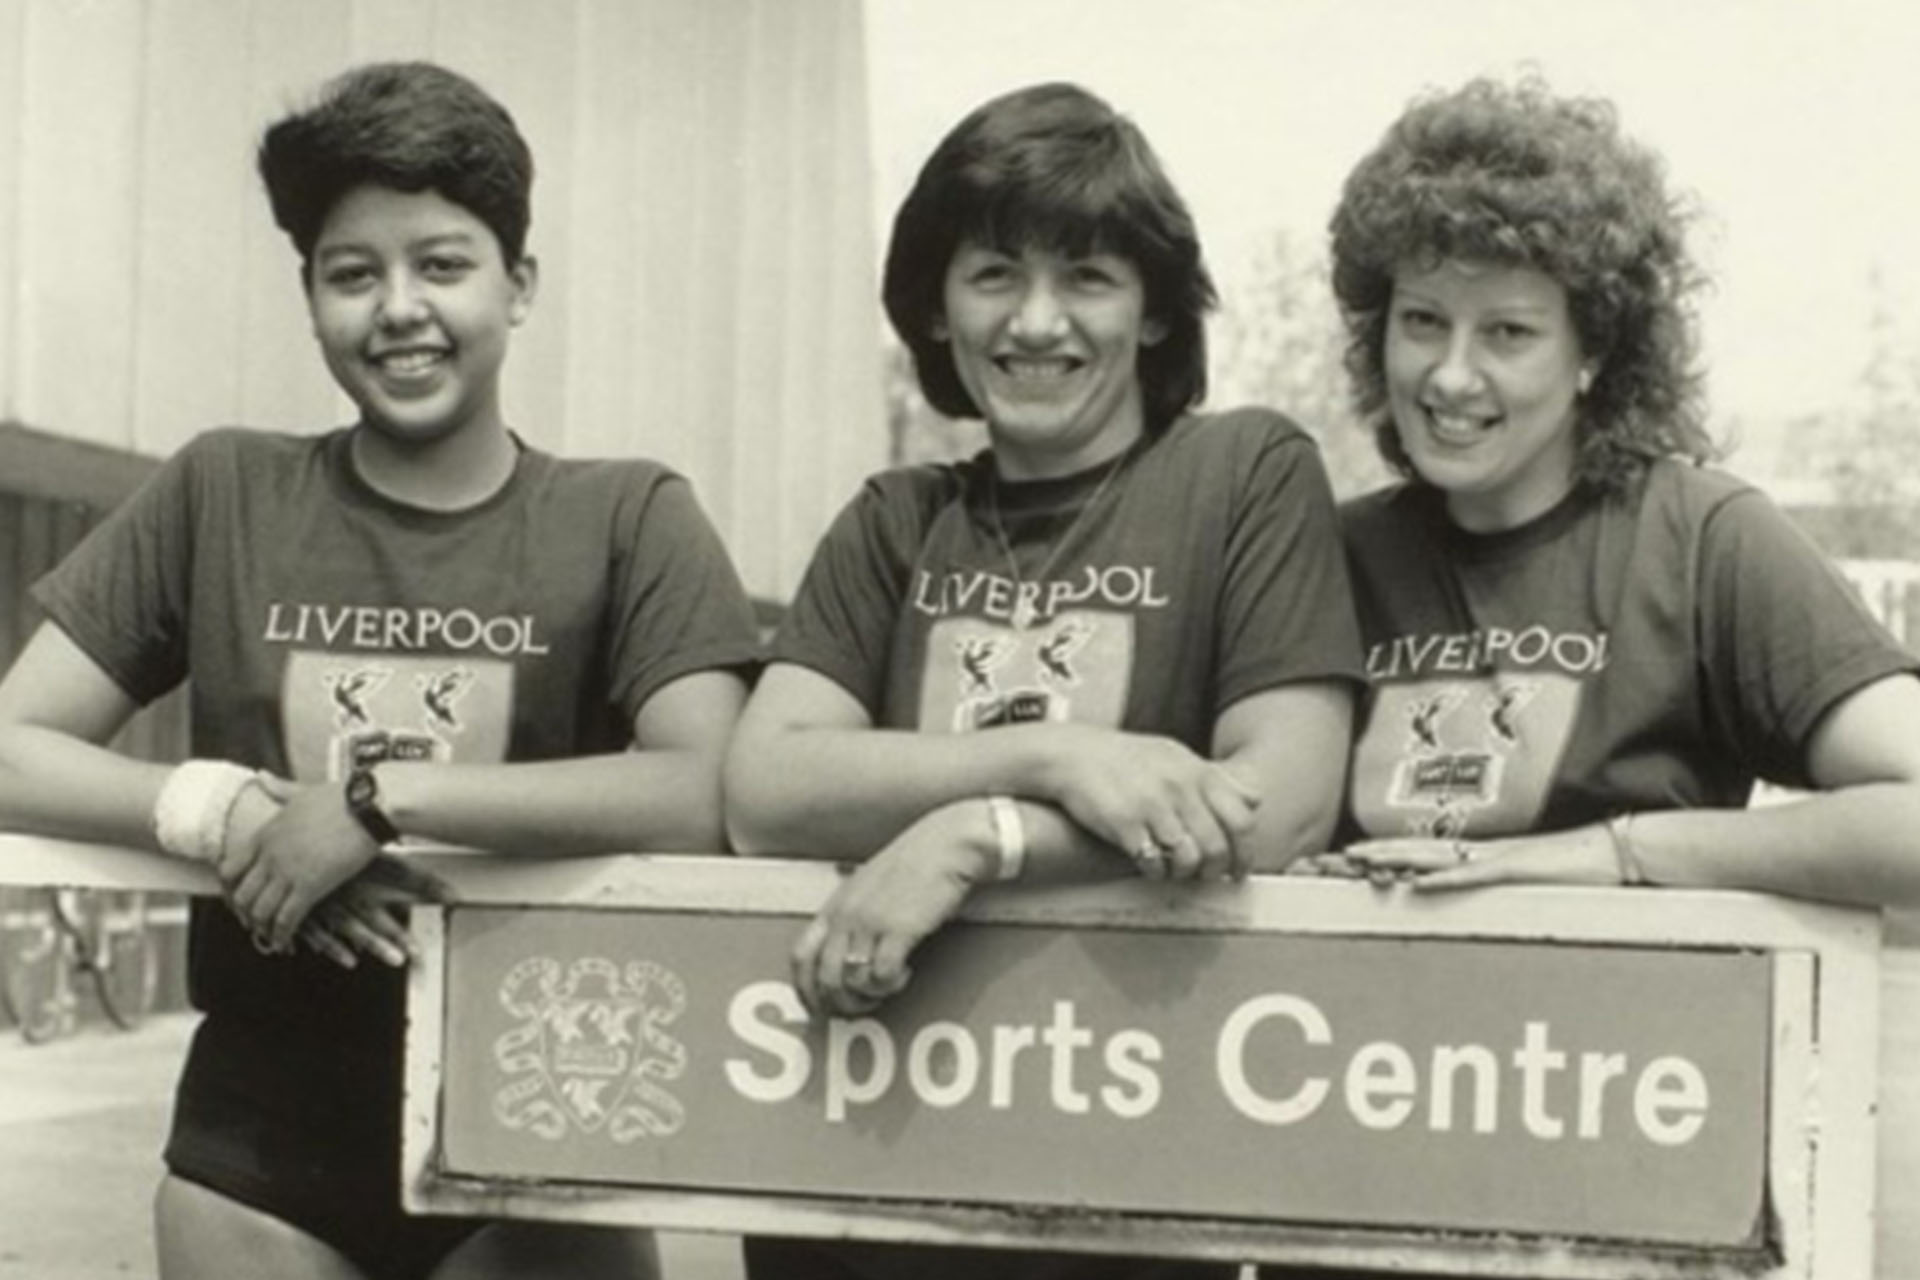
[881, 84, 1215, 432]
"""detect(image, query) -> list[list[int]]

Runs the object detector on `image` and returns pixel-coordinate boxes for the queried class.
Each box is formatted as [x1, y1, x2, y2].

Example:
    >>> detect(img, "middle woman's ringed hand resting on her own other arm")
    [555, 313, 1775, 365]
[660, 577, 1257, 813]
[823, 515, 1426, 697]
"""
[1035, 723, 1260, 879]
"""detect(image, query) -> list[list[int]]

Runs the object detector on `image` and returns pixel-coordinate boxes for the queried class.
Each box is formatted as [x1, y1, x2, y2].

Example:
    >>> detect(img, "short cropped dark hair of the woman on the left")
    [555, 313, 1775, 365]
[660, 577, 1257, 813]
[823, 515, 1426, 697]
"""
[257, 61, 534, 267]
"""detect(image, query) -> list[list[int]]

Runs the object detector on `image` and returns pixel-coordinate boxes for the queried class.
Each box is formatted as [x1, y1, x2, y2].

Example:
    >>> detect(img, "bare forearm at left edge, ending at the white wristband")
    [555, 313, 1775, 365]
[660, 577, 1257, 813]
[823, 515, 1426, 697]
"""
[0, 723, 169, 850]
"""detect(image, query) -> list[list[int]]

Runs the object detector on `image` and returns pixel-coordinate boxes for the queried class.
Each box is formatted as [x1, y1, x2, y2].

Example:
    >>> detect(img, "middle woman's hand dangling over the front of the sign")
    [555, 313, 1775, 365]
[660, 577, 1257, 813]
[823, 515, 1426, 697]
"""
[793, 800, 989, 1017]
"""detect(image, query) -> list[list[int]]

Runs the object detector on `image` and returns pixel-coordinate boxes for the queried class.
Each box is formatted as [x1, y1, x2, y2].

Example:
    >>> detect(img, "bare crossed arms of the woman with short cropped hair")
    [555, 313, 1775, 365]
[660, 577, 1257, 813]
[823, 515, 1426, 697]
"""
[0, 626, 745, 946]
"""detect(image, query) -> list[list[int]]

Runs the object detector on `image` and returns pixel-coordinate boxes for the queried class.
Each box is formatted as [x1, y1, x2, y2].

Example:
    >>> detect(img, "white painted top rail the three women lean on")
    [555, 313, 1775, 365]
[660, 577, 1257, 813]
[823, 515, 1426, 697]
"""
[0, 835, 1880, 959]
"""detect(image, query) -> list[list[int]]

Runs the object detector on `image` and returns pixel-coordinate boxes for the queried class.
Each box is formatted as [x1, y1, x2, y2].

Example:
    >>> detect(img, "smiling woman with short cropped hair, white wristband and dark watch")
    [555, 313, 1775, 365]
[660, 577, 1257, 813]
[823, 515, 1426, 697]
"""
[0, 63, 756, 1280]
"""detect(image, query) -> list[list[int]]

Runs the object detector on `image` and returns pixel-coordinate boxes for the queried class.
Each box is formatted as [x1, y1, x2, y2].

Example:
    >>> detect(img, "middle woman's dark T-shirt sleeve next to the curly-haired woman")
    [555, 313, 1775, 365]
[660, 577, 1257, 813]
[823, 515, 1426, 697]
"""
[1213, 428, 1365, 714]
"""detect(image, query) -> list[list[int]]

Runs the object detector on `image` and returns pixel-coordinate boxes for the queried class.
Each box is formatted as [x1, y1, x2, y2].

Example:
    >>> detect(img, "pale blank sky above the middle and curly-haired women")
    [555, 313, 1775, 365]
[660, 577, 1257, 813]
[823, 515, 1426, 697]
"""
[866, 0, 1920, 468]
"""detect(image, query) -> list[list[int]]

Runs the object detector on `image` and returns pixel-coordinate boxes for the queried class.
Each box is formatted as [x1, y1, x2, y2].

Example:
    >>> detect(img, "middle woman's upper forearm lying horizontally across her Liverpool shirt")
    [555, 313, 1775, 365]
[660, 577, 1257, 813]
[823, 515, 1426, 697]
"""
[726, 725, 1075, 860]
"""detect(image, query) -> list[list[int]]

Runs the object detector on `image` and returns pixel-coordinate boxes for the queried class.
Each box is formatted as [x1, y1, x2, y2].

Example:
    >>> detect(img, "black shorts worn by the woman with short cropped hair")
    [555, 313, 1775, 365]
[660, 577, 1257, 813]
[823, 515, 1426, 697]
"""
[165, 1015, 486, 1280]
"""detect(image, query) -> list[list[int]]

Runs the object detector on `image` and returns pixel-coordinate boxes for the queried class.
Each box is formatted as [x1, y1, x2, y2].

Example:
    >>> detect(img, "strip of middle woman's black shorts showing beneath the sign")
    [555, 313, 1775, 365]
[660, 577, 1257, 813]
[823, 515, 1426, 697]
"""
[741, 1236, 1240, 1280]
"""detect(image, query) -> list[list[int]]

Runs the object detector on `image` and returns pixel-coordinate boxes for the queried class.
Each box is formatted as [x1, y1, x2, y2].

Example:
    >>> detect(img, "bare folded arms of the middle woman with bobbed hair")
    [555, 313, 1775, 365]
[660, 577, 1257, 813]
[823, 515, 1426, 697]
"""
[728, 668, 1352, 1013]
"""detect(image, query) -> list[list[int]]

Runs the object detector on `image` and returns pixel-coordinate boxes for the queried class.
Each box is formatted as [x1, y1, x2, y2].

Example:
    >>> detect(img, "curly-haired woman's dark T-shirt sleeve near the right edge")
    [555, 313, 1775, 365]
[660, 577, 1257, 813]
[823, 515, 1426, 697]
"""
[1695, 489, 1920, 787]
